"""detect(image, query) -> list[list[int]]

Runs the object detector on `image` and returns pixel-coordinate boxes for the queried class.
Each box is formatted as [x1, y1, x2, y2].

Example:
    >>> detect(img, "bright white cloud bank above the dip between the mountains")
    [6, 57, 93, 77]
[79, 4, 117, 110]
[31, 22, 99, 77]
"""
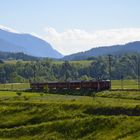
[45, 27, 140, 55]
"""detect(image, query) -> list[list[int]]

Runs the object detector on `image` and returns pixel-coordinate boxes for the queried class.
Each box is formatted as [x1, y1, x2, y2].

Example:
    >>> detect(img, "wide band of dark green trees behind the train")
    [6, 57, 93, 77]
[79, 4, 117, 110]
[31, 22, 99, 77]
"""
[0, 54, 138, 83]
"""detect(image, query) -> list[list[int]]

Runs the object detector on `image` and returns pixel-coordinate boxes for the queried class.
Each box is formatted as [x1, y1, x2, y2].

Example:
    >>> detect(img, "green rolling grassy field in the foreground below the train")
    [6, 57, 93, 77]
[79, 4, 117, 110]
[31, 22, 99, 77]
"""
[0, 91, 140, 140]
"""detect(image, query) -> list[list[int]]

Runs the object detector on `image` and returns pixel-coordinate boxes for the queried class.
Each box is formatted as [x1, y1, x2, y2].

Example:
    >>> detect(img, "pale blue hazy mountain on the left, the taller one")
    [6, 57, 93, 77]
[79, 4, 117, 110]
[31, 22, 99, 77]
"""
[0, 29, 62, 58]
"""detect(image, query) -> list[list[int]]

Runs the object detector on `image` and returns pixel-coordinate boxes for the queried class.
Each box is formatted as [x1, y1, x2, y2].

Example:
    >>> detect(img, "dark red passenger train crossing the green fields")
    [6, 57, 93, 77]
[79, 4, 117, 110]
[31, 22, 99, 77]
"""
[30, 81, 111, 91]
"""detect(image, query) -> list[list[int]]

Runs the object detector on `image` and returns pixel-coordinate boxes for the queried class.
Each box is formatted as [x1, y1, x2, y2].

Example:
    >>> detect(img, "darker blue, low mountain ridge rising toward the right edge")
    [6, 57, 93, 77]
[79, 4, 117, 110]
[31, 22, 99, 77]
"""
[63, 41, 140, 60]
